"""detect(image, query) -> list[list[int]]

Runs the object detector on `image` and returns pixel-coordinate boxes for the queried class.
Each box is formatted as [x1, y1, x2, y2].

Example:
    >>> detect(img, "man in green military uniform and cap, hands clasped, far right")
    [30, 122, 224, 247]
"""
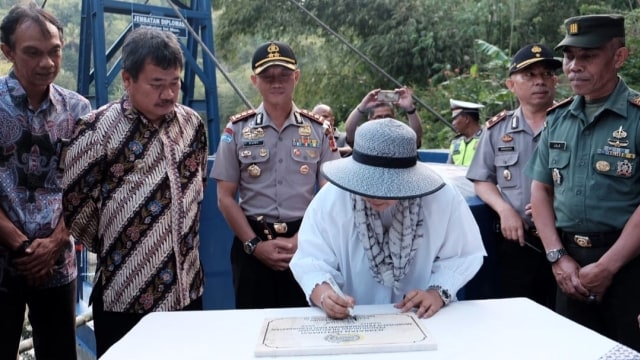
[526, 15, 640, 350]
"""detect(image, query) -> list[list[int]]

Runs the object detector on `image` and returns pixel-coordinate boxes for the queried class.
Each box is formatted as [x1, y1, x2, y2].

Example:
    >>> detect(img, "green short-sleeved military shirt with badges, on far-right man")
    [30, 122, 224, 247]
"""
[527, 79, 640, 232]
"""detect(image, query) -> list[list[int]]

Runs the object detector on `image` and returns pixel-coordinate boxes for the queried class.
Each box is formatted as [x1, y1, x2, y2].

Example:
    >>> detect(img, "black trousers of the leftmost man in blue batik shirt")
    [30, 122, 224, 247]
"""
[0, 268, 77, 360]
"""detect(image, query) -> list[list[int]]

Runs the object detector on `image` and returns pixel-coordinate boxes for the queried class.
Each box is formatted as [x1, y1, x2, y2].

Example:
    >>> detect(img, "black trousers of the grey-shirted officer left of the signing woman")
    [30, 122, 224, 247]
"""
[231, 221, 309, 309]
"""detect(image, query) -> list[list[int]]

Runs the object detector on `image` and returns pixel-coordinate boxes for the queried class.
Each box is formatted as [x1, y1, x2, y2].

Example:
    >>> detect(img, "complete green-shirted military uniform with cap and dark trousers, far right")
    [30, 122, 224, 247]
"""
[527, 15, 640, 351]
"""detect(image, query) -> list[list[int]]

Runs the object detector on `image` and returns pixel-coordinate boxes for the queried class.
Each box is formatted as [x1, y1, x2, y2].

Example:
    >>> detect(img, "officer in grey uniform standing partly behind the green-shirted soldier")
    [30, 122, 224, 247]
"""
[467, 44, 562, 309]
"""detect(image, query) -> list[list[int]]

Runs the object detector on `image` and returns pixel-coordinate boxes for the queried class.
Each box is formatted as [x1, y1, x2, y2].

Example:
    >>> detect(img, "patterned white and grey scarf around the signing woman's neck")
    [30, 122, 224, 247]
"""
[351, 194, 424, 287]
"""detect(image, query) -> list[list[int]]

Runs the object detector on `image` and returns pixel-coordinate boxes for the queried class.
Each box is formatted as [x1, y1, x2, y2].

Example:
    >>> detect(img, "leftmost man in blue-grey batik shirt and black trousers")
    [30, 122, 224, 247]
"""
[0, 4, 91, 360]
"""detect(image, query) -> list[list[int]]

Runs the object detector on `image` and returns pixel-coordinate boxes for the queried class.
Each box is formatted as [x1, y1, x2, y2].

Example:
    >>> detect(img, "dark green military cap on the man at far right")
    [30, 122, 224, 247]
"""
[555, 14, 624, 50]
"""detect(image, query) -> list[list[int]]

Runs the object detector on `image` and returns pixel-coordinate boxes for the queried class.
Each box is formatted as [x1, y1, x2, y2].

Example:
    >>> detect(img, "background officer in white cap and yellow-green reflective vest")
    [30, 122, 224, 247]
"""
[447, 99, 484, 166]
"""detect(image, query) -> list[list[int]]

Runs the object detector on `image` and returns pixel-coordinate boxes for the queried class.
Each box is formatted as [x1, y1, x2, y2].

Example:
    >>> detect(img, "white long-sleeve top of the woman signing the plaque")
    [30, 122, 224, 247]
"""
[290, 183, 486, 305]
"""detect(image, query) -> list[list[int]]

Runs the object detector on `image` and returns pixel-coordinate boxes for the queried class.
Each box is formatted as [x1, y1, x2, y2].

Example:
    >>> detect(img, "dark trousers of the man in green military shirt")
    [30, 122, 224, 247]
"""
[556, 241, 640, 351]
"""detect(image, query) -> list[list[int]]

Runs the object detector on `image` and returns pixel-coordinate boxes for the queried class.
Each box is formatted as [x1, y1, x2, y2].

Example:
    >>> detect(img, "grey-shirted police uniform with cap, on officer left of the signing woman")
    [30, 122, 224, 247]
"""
[211, 41, 340, 308]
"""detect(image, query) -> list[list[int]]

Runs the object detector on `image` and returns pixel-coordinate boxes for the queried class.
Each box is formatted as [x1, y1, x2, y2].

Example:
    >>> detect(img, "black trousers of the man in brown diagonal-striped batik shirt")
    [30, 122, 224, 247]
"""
[92, 281, 203, 360]
